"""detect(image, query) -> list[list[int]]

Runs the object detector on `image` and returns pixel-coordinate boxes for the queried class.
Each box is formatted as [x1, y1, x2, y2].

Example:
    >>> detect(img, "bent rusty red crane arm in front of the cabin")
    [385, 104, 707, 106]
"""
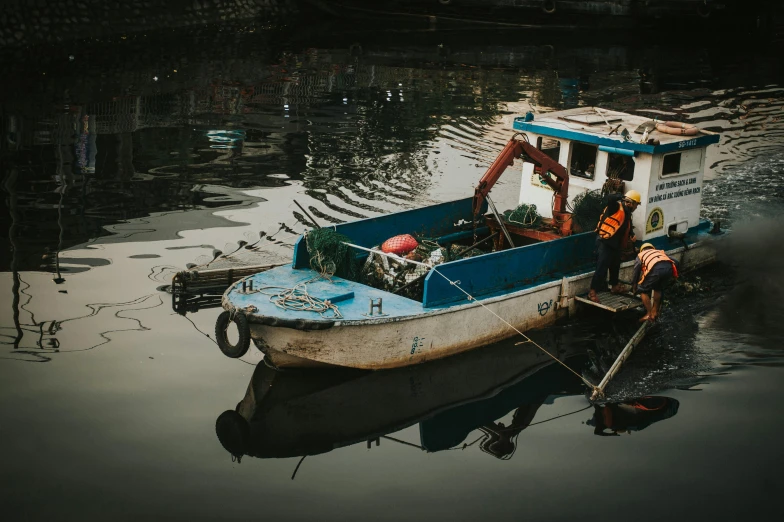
[473, 134, 569, 216]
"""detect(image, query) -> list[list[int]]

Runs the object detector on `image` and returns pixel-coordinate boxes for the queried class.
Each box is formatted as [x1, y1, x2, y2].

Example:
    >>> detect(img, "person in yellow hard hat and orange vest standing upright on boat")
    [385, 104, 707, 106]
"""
[588, 190, 640, 303]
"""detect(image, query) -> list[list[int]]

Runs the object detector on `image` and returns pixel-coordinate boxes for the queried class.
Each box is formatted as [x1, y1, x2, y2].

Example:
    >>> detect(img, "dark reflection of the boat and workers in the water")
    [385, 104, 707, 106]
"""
[215, 338, 678, 459]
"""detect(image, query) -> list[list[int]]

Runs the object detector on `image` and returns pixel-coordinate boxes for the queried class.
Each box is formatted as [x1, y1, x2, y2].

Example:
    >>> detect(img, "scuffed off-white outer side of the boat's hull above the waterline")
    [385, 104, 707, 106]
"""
[251, 241, 716, 370]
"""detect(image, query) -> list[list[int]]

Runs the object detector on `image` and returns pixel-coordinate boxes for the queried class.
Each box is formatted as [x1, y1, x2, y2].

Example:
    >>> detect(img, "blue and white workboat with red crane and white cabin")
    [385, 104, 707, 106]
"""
[216, 107, 719, 369]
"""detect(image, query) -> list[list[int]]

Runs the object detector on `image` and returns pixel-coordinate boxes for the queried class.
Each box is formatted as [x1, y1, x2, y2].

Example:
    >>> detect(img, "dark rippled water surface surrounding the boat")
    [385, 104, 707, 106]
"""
[0, 14, 784, 520]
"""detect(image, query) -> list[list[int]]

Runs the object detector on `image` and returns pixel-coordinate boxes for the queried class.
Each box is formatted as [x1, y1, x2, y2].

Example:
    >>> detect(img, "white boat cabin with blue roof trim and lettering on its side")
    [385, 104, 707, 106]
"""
[514, 107, 719, 240]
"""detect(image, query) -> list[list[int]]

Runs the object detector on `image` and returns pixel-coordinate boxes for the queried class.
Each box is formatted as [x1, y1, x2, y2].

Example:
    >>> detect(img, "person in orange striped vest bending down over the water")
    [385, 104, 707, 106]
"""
[632, 243, 678, 322]
